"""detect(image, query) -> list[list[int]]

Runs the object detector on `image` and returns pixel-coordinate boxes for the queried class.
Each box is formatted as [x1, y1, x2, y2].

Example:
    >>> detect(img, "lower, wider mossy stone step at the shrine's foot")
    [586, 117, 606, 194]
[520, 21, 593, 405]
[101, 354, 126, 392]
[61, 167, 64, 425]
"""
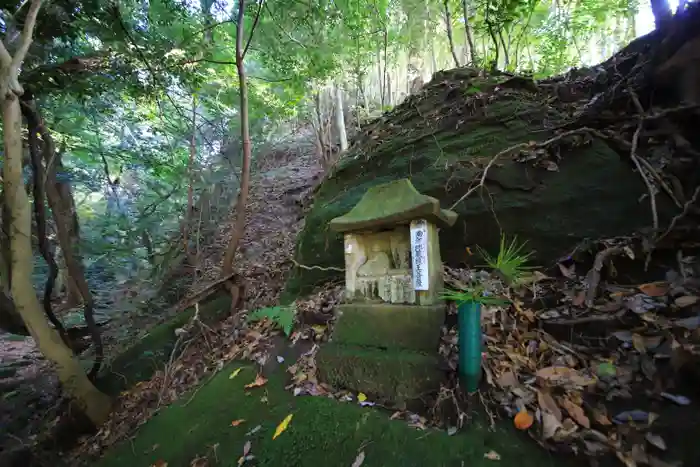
[316, 342, 444, 403]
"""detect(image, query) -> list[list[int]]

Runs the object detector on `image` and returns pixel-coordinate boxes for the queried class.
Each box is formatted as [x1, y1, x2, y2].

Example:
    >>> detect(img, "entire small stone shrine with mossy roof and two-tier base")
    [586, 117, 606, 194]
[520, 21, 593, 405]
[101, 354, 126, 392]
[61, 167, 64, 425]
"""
[317, 179, 457, 402]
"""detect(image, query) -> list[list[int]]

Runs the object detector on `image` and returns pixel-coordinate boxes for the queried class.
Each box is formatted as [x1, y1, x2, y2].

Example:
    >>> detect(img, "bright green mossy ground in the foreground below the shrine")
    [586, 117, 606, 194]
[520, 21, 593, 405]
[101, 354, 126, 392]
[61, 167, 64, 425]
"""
[95, 363, 566, 467]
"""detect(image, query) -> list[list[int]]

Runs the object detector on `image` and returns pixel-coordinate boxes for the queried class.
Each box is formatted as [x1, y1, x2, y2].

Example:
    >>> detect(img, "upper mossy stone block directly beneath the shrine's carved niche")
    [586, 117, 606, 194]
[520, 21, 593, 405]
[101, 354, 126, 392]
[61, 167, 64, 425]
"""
[333, 303, 445, 352]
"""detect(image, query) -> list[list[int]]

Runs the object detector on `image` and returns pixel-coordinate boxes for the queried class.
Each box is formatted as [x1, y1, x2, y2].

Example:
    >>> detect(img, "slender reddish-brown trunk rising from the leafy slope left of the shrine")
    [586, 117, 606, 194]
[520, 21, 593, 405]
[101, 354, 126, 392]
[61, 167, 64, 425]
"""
[222, 0, 253, 276]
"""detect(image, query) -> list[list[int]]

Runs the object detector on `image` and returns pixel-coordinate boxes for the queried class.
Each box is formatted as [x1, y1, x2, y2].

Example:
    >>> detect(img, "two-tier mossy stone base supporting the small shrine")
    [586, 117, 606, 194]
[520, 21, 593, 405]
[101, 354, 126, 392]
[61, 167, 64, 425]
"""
[316, 303, 445, 402]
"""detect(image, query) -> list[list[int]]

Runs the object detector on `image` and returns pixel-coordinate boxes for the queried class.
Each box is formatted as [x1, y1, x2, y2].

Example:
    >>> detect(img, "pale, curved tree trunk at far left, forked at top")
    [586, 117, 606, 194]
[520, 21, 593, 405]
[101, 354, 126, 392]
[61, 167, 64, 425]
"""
[0, 0, 111, 425]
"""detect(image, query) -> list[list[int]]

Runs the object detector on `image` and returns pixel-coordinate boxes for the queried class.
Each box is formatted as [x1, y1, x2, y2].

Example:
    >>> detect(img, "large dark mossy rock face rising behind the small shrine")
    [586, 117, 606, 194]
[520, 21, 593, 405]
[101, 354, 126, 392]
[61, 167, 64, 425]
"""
[287, 69, 651, 298]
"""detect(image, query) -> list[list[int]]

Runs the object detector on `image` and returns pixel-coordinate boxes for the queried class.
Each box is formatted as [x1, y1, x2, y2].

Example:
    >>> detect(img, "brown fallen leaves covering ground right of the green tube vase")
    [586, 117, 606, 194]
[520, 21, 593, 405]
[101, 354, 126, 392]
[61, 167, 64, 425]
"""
[442, 238, 700, 465]
